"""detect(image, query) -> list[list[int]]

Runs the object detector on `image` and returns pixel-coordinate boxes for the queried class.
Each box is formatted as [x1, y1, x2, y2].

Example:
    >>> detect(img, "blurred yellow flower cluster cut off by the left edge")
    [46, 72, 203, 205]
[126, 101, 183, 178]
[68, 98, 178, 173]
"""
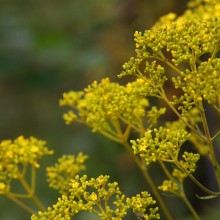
[0, 136, 53, 194]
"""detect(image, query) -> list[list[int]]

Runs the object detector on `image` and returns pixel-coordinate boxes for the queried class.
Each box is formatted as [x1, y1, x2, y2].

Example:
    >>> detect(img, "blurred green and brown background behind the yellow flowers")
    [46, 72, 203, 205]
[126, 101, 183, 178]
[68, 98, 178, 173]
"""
[0, 0, 220, 220]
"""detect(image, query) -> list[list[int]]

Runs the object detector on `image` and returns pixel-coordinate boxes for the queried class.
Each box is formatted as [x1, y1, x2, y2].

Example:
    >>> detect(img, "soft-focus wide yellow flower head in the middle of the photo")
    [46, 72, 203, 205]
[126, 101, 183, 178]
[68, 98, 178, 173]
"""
[60, 78, 149, 131]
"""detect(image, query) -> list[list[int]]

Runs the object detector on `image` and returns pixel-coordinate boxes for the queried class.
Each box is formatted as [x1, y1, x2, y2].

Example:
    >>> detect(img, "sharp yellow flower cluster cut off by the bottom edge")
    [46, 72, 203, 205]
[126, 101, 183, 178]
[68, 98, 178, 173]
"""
[31, 175, 160, 220]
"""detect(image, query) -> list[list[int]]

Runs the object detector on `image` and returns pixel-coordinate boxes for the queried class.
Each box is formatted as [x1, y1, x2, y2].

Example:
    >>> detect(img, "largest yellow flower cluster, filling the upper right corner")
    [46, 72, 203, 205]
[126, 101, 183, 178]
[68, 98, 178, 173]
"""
[119, 0, 220, 113]
